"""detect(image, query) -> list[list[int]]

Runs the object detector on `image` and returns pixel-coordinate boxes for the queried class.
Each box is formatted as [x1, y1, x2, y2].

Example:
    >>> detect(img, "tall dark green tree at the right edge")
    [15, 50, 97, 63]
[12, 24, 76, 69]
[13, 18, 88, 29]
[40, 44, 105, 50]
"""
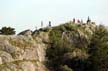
[89, 25, 108, 71]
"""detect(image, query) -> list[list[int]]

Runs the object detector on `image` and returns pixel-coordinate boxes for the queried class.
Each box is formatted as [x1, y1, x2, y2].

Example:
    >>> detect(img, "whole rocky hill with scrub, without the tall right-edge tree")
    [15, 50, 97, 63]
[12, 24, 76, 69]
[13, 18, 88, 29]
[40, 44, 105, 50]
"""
[0, 22, 107, 71]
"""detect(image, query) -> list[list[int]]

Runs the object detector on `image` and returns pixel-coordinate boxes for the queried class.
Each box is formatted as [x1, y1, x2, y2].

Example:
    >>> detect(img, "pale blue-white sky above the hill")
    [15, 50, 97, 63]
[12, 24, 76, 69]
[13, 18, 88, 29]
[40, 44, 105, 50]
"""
[0, 0, 108, 33]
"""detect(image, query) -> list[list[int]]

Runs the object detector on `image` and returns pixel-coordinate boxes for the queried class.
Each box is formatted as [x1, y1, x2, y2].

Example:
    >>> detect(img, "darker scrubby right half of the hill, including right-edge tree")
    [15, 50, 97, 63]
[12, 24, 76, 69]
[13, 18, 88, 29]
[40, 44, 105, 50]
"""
[46, 23, 108, 71]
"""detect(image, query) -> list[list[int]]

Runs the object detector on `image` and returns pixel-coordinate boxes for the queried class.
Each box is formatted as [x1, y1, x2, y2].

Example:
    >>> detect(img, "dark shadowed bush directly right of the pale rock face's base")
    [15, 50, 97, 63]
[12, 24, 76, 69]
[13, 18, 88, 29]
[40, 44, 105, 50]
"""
[46, 41, 72, 70]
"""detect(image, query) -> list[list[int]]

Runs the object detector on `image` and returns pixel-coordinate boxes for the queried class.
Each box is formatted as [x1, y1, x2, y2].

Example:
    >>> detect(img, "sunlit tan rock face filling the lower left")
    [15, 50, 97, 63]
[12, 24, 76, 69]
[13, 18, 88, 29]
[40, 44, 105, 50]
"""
[0, 30, 47, 71]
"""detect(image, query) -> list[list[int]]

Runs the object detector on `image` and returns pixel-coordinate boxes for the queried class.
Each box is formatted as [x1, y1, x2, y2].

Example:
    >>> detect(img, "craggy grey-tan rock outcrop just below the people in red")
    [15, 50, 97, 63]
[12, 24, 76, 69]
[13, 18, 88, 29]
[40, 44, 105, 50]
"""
[62, 23, 96, 48]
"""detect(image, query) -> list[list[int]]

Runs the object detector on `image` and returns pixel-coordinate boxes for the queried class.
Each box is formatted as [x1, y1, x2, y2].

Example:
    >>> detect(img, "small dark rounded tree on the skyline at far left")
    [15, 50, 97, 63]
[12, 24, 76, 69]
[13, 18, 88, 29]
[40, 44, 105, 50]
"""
[0, 27, 15, 35]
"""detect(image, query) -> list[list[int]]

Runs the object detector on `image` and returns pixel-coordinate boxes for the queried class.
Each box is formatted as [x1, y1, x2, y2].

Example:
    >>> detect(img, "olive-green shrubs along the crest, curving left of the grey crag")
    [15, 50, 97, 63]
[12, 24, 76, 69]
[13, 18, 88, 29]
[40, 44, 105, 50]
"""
[49, 23, 77, 44]
